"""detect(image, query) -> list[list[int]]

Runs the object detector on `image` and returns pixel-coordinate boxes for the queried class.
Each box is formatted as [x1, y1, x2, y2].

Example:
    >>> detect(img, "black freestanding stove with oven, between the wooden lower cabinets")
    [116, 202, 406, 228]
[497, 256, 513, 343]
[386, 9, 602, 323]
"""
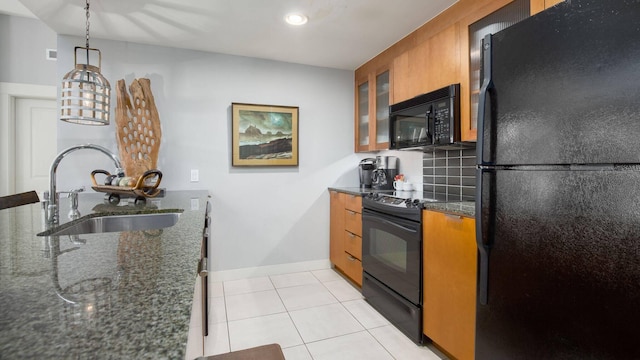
[362, 193, 423, 343]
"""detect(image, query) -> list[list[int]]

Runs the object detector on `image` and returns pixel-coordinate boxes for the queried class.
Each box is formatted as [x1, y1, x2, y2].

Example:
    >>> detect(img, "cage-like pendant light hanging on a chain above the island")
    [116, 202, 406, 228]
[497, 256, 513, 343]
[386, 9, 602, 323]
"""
[60, 0, 111, 125]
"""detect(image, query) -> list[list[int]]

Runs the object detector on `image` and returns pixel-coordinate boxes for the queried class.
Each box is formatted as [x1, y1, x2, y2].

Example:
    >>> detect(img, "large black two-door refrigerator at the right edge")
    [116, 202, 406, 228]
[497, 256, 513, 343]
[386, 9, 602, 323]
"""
[475, 0, 640, 360]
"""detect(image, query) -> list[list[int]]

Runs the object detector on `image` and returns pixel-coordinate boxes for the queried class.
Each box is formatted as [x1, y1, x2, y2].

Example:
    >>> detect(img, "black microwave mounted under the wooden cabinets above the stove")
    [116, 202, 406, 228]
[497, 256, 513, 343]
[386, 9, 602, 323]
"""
[389, 84, 460, 150]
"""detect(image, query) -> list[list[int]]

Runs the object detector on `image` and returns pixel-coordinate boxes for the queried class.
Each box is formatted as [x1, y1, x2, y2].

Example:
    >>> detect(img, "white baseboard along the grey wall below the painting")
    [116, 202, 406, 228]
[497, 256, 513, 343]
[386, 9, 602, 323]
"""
[209, 259, 331, 281]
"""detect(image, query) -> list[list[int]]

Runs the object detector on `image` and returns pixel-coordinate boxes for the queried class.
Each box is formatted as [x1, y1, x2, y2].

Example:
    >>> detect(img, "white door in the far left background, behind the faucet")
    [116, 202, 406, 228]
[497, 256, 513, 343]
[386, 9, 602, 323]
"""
[15, 98, 57, 194]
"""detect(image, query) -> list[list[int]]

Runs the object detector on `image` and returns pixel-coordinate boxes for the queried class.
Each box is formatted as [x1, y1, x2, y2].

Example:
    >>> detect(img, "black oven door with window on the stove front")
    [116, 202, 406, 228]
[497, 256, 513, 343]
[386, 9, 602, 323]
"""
[362, 208, 422, 305]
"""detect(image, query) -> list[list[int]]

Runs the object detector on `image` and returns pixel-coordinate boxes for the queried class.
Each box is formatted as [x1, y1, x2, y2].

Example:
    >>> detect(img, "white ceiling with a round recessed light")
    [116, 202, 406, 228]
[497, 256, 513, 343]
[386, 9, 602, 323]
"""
[0, 0, 457, 70]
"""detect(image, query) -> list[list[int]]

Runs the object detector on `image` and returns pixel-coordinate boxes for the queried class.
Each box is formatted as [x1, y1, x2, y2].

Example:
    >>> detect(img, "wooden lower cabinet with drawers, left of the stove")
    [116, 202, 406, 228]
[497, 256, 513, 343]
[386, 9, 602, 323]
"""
[329, 190, 362, 286]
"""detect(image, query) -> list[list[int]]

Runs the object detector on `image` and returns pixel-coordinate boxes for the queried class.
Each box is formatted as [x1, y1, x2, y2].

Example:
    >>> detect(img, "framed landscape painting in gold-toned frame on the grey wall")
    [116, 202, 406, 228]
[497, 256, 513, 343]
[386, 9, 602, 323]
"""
[231, 103, 299, 166]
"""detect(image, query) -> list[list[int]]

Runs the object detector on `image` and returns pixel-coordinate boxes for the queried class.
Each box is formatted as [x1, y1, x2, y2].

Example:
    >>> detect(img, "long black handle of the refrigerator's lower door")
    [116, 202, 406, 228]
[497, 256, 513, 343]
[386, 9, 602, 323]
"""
[476, 168, 491, 305]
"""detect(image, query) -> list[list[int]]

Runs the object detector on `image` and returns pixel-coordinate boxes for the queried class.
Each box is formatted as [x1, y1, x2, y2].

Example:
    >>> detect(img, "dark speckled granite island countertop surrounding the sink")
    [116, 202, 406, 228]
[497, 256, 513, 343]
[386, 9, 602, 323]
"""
[0, 191, 208, 359]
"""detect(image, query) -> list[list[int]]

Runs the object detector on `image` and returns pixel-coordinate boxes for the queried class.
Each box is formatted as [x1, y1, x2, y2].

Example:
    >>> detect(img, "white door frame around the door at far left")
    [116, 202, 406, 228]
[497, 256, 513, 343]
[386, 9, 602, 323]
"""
[0, 82, 58, 194]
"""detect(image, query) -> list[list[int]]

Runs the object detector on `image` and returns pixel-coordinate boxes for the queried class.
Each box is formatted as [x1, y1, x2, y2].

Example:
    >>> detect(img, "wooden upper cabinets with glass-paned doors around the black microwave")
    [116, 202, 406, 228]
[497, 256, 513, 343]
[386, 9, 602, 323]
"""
[355, 0, 562, 151]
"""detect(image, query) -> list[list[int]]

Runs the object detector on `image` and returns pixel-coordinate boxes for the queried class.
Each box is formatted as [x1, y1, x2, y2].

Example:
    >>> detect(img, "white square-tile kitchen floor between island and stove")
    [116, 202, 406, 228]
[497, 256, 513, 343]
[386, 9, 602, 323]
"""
[204, 269, 441, 360]
